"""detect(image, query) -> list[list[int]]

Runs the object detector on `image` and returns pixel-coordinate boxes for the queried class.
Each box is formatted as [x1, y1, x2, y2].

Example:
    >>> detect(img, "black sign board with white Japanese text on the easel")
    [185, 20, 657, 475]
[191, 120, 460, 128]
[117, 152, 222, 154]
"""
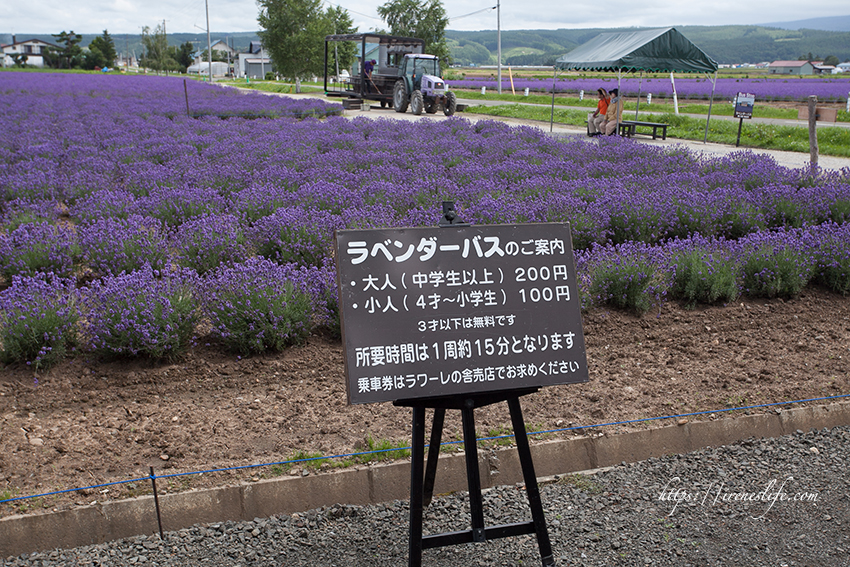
[336, 223, 588, 404]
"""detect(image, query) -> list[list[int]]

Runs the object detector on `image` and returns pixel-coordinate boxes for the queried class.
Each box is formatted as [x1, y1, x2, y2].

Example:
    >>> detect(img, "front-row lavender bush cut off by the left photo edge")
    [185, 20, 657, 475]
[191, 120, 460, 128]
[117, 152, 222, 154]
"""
[0, 274, 79, 370]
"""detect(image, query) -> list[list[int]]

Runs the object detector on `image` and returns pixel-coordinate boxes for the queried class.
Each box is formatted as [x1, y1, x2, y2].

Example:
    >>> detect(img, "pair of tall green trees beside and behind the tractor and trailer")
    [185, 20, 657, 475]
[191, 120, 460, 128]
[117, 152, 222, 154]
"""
[257, 0, 451, 80]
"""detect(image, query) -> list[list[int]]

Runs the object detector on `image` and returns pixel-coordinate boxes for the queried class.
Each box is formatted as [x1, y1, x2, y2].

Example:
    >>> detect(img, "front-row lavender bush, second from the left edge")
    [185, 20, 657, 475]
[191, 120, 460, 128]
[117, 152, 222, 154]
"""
[83, 265, 199, 359]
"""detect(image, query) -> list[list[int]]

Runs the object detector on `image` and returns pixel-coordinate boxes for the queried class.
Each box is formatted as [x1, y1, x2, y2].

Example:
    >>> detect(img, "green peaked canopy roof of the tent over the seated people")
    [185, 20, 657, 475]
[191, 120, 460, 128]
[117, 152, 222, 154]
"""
[555, 28, 717, 73]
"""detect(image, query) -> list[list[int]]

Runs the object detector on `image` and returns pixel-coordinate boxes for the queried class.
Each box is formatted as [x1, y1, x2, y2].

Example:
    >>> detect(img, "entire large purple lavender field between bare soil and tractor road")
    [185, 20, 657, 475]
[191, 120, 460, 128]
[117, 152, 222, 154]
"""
[0, 73, 850, 368]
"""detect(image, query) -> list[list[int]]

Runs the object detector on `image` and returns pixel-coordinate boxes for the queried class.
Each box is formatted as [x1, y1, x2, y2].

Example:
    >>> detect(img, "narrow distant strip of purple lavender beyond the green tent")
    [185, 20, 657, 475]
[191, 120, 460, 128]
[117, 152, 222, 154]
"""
[451, 77, 850, 102]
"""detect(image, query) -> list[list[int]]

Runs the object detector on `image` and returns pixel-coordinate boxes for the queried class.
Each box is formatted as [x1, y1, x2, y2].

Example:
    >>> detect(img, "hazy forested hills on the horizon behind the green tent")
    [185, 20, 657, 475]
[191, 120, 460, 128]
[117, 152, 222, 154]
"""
[446, 24, 850, 65]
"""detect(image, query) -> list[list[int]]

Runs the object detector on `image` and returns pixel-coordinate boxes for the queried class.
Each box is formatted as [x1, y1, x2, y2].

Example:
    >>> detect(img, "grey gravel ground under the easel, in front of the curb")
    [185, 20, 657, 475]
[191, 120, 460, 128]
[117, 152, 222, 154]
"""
[0, 427, 850, 567]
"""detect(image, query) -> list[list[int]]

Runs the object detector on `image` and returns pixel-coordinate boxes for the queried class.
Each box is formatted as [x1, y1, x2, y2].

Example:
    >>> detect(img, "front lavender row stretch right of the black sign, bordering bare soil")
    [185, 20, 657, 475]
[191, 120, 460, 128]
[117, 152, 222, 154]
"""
[576, 223, 850, 313]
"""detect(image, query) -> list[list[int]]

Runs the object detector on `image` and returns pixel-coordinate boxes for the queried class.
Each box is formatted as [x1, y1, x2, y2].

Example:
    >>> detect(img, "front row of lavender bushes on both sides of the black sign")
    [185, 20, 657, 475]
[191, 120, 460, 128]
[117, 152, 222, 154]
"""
[0, 223, 850, 369]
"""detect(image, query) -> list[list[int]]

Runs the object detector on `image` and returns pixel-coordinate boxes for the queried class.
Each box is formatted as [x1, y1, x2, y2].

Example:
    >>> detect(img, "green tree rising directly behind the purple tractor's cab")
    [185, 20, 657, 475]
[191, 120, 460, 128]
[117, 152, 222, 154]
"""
[378, 0, 452, 63]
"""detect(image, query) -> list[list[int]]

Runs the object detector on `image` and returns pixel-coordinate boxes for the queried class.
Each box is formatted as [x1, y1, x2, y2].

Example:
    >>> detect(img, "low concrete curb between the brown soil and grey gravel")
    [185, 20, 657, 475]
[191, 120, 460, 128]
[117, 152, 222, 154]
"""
[0, 402, 850, 559]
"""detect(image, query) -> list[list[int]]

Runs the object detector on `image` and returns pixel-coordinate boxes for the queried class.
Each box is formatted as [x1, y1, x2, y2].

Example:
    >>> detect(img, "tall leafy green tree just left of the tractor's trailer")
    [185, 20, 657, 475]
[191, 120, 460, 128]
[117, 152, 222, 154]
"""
[257, 0, 333, 80]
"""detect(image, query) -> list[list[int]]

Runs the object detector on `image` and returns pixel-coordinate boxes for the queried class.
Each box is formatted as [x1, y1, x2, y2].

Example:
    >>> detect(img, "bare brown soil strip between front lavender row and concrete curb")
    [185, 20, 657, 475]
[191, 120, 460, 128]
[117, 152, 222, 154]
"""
[0, 288, 850, 516]
